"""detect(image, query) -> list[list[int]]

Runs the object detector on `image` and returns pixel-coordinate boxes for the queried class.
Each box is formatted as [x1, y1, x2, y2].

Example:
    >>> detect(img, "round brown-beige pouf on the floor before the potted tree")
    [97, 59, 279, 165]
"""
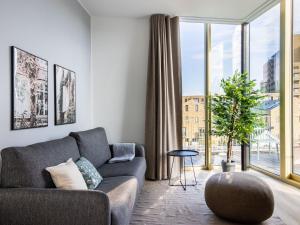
[205, 172, 274, 224]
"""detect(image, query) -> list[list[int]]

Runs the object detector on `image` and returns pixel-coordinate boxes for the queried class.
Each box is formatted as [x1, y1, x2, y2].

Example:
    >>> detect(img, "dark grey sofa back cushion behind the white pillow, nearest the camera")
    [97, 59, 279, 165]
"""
[1, 137, 80, 188]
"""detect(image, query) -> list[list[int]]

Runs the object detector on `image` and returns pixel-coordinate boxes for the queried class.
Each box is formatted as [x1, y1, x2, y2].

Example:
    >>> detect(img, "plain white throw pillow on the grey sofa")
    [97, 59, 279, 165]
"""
[46, 158, 88, 190]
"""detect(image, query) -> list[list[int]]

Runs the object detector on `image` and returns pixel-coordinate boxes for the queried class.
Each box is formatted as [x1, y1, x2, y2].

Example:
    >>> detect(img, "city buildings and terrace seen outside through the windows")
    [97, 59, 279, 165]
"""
[182, 35, 300, 170]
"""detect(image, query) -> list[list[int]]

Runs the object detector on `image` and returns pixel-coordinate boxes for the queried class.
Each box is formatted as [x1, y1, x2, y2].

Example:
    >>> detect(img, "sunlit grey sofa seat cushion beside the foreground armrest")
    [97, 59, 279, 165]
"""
[96, 176, 138, 225]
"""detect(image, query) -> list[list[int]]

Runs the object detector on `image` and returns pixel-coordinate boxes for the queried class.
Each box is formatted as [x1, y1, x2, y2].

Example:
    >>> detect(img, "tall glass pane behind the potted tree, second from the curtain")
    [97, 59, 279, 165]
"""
[211, 24, 241, 165]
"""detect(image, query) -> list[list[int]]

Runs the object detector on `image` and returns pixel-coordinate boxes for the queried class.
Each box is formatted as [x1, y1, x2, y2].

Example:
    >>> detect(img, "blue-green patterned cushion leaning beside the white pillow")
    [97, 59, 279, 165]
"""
[76, 157, 103, 189]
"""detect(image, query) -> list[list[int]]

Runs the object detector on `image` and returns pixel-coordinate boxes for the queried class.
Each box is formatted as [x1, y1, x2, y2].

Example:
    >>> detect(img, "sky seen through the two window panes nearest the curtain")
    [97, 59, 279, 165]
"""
[180, 22, 241, 95]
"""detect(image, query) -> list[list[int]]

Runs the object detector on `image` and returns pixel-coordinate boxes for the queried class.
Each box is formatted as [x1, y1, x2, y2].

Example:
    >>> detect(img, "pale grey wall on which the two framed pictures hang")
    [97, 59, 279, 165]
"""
[0, 0, 92, 149]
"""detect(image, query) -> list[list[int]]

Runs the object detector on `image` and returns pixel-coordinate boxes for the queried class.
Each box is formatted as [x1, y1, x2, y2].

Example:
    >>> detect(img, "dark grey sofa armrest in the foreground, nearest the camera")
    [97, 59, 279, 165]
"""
[0, 188, 110, 225]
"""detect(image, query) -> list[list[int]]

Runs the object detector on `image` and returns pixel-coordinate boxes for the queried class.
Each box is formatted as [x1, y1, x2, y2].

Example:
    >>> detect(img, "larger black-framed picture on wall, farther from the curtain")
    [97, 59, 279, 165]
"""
[11, 46, 48, 130]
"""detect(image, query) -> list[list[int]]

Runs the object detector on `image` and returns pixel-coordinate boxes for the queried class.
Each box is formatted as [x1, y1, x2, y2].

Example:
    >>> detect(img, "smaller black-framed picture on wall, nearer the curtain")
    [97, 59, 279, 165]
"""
[54, 65, 76, 125]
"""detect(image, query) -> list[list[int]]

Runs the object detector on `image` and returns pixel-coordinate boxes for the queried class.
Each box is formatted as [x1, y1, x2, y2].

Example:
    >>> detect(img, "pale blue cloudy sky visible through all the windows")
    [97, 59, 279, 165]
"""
[180, 0, 300, 95]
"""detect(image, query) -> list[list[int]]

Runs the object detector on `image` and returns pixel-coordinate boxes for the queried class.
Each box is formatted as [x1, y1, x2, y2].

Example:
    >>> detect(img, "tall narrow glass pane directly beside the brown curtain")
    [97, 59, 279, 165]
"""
[180, 22, 205, 165]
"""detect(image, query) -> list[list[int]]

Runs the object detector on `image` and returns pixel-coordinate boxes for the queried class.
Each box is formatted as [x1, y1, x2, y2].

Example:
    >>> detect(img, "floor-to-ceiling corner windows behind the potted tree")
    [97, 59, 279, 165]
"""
[180, 0, 300, 185]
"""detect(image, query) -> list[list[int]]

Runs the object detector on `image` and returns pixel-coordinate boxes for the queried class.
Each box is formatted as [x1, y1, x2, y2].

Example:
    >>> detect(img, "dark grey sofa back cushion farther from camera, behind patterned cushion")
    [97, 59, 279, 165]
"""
[70, 127, 111, 168]
